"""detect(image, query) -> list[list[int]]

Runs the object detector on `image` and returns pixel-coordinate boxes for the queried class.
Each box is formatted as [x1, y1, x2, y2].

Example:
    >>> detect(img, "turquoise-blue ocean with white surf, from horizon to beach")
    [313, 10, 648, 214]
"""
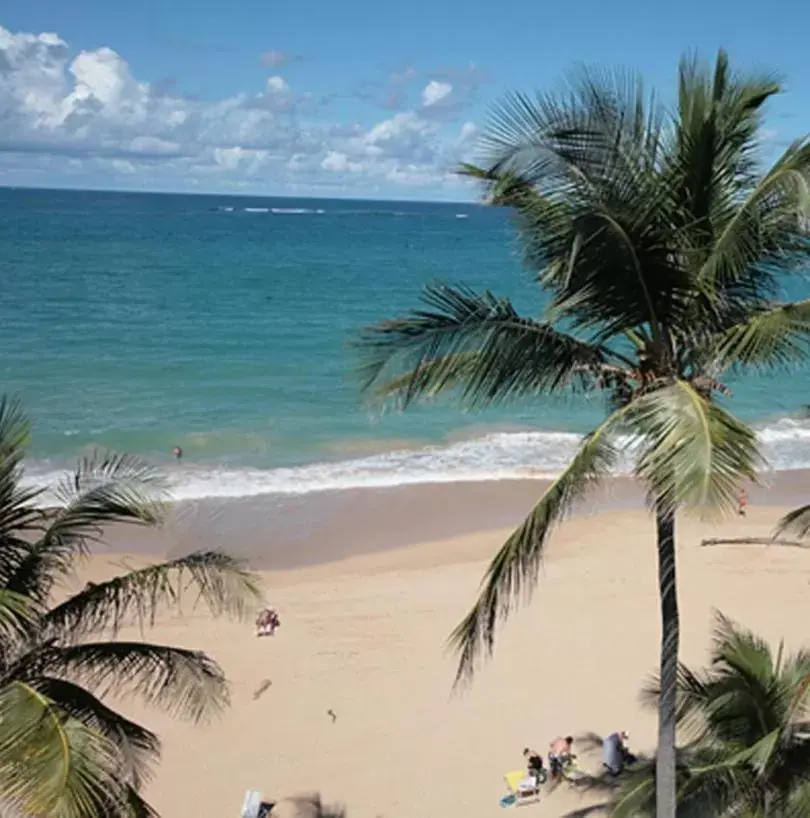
[0, 188, 810, 499]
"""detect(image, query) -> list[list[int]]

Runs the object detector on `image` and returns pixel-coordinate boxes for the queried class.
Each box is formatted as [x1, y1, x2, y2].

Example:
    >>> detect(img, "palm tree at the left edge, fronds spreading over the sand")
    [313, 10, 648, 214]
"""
[0, 399, 258, 818]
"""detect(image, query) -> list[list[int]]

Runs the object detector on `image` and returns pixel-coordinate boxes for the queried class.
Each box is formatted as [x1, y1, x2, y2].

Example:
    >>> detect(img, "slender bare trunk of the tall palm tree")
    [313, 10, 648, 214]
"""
[655, 502, 680, 818]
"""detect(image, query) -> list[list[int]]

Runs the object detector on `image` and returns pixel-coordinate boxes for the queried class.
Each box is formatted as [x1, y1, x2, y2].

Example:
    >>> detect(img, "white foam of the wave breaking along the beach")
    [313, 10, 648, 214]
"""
[20, 418, 810, 500]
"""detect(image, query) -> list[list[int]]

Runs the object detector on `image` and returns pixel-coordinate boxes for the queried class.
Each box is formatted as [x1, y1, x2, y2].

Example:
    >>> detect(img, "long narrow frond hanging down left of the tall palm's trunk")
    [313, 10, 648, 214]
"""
[450, 412, 622, 686]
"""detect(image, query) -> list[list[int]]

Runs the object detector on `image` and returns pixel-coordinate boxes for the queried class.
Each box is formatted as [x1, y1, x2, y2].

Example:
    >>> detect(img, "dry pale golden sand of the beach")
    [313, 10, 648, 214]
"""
[80, 484, 810, 818]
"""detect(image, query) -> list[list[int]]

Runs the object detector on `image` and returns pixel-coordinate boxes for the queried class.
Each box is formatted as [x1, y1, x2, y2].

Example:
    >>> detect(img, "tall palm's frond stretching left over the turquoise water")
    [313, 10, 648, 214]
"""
[358, 284, 616, 407]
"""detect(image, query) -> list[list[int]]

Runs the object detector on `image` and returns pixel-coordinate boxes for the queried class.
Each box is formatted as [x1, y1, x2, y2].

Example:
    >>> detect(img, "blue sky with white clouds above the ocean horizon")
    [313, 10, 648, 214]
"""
[0, 0, 810, 201]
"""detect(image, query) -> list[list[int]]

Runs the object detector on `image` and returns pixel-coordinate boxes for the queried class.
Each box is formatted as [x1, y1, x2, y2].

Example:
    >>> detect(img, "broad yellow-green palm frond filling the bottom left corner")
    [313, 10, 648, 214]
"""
[0, 681, 122, 818]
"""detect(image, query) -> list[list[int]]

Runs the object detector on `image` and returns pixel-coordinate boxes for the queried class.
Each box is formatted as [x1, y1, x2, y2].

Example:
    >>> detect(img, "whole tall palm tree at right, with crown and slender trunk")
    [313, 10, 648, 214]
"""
[359, 52, 810, 818]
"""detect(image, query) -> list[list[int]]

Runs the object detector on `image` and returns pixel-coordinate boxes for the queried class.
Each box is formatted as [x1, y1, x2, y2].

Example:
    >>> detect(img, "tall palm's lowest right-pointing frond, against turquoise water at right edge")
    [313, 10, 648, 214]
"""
[708, 300, 810, 372]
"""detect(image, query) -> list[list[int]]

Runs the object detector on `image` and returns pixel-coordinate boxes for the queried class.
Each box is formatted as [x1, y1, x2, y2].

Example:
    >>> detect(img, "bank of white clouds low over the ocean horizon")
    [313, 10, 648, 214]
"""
[0, 22, 477, 192]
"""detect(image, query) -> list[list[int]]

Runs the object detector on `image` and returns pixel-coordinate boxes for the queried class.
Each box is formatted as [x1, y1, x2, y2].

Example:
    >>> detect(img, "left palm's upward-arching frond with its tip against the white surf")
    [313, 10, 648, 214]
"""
[6, 452, 166, 602]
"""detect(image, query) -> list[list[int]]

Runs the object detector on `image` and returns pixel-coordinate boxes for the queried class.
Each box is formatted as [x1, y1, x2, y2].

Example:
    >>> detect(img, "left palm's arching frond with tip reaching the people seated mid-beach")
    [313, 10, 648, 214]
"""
[42, 551, 260, 642]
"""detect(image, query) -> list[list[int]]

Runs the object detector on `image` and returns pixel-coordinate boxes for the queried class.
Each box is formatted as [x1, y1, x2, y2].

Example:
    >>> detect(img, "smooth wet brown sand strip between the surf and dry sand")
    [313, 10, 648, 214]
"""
[99, 470, 810, 571]
